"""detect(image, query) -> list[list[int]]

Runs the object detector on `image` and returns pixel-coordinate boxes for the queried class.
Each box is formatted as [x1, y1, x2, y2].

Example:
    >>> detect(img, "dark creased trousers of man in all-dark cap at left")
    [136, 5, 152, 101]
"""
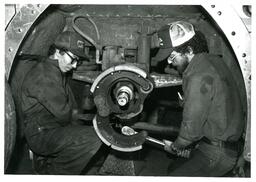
[26, 125, 101, 174]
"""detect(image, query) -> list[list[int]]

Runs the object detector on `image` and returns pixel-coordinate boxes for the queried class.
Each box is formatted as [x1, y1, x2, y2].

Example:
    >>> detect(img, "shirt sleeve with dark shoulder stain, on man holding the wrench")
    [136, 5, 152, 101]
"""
[174, 75, 214, 148]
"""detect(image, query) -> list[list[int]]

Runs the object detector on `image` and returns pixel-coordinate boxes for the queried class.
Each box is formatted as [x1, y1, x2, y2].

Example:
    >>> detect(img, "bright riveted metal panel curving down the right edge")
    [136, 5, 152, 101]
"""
[203, 2, 251, 161]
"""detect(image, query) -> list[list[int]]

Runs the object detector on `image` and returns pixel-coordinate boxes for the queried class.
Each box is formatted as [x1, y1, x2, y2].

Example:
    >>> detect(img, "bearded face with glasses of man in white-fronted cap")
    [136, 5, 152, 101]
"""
[168, 51, 189, 74]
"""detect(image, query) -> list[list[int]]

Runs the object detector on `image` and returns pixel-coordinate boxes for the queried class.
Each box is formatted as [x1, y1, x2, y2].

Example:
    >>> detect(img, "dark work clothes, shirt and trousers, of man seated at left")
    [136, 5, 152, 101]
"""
[21, 59, 101, 174]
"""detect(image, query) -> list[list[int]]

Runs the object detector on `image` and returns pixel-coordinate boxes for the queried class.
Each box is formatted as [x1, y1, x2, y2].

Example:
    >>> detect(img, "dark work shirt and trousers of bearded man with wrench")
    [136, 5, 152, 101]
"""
[169, 53, 245, 176]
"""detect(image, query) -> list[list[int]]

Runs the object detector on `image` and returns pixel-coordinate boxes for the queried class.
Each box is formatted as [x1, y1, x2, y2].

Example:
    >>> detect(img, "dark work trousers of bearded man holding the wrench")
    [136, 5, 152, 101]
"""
[168, 142, 238, 177]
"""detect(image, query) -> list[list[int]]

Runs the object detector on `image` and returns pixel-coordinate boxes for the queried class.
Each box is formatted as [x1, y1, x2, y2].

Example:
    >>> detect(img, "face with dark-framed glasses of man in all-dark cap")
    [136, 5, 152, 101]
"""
[58, 51, 77, 73]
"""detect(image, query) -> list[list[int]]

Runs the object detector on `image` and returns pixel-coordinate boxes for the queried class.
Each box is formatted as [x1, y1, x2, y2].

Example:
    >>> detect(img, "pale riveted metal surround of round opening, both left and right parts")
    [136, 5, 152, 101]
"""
[5, 4, 251, 161]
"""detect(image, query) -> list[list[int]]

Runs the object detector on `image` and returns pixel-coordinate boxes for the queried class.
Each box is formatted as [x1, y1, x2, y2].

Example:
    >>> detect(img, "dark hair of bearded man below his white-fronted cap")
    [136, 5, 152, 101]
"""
[174, 31, 209, 54]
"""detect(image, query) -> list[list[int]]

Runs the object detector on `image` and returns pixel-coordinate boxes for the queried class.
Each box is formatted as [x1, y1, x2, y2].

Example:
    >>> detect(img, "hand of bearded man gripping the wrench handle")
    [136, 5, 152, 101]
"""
[163, 140, 191, 158]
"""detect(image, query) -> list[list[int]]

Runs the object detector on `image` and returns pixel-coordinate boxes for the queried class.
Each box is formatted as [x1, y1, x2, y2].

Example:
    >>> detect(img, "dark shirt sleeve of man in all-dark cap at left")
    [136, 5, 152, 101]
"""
[27, 72, 73, 124]
